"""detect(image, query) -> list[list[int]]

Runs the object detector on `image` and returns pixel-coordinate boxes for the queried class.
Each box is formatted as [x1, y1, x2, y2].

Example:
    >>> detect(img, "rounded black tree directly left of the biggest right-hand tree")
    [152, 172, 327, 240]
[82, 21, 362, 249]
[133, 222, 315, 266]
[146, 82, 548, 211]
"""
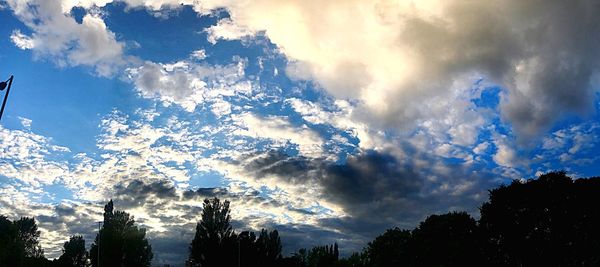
[410, 212, 485, 267]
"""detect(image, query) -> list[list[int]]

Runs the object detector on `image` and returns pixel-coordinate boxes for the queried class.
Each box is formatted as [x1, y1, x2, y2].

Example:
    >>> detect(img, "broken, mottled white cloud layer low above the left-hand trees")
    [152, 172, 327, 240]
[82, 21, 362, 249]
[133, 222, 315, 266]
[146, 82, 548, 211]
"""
[0, 112, 344, 257]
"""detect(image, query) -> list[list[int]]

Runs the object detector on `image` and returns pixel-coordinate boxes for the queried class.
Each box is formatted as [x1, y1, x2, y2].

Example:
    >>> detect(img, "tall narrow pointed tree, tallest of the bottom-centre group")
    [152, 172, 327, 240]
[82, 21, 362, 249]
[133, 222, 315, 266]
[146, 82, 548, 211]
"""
[189, 197, 238, 267]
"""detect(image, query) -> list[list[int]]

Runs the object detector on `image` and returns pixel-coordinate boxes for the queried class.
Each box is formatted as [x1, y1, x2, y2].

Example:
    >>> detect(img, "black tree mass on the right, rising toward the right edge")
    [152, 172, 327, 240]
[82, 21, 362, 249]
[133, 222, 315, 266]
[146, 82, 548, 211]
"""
[350, 172, 600, 267]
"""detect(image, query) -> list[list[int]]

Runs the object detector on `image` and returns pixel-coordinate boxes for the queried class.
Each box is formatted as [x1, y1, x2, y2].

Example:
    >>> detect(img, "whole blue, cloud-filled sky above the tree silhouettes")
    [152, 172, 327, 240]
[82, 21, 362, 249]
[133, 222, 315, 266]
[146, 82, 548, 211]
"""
[0, 0, 600, 264]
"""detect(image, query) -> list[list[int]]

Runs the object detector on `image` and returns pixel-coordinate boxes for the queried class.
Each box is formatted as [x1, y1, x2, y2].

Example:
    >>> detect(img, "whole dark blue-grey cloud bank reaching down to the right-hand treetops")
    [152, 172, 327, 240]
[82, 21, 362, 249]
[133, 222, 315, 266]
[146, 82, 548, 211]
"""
[239, 149, 495, 250]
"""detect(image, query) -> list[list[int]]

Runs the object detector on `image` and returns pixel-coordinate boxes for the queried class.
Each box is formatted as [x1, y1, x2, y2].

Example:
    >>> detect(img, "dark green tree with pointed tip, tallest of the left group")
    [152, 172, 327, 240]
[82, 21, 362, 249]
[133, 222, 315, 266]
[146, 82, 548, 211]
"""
[89, 200, 153, 267]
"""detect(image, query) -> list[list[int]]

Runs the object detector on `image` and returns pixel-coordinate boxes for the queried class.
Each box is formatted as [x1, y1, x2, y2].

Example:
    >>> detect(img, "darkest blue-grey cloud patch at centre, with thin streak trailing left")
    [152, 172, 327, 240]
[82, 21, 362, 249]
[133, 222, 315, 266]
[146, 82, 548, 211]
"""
[244, 151, 422, 217]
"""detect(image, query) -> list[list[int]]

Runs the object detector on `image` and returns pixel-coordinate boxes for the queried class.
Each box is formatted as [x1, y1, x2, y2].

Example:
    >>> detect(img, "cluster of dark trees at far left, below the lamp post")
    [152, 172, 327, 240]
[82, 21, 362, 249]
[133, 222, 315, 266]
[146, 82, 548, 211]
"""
[0, 200, 152, 267]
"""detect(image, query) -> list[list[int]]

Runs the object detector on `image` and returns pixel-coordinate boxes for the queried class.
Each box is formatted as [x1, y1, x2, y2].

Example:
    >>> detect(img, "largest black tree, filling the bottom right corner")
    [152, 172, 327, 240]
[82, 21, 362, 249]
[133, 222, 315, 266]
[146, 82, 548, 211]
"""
[480, 172, 600, 266]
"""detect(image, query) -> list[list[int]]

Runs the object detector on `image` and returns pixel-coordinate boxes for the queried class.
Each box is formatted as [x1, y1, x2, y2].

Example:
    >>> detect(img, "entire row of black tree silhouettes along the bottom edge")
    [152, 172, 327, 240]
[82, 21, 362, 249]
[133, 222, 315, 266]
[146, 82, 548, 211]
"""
[0, 172, 600, 267]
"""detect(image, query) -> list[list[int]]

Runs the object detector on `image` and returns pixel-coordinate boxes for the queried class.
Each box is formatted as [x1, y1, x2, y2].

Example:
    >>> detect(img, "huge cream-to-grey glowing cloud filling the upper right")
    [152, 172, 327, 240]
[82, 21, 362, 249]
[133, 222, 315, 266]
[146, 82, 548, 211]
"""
[195, 1, 600, 136]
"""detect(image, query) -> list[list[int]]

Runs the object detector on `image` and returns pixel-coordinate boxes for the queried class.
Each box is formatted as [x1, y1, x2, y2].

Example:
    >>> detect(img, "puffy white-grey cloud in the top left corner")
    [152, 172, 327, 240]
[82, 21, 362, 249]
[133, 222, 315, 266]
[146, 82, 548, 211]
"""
[7, 0, 127, 76]
